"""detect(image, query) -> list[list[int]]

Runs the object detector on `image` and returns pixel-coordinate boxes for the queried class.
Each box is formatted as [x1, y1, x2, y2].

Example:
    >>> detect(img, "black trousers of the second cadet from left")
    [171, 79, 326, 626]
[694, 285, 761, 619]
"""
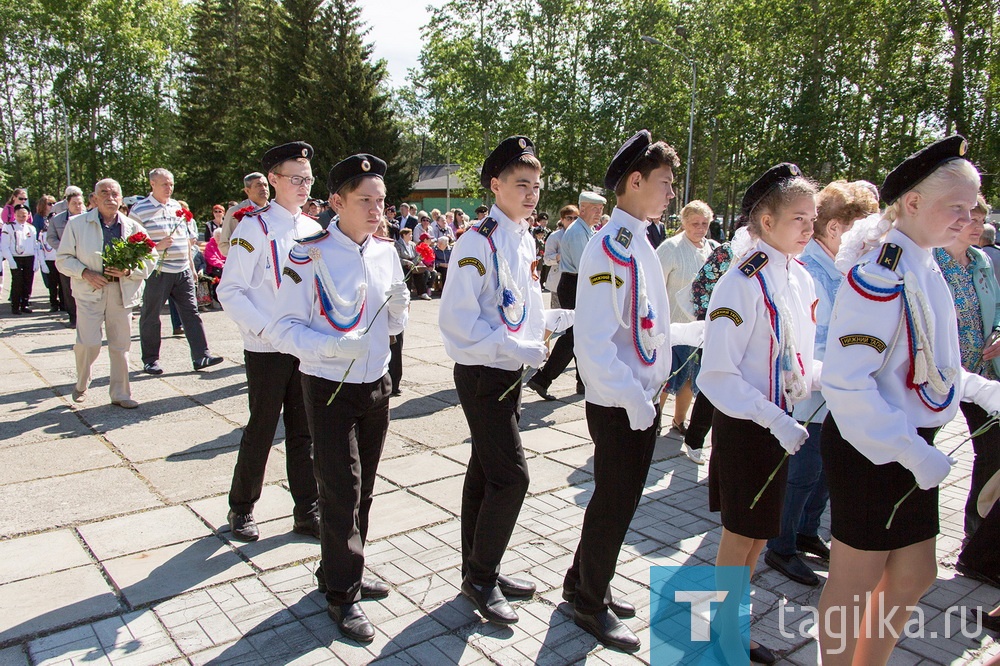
[302, 374, 390, 605]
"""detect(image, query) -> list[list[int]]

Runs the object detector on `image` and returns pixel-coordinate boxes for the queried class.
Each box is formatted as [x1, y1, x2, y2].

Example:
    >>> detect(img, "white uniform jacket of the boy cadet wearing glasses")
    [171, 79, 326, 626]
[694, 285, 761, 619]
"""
[217, 202, 320, 352]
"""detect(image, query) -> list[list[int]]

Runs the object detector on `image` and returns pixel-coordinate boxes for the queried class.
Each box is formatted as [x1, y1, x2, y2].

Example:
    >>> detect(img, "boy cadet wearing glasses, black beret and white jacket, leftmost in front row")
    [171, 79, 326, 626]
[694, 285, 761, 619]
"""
[218, 141, 321, 541]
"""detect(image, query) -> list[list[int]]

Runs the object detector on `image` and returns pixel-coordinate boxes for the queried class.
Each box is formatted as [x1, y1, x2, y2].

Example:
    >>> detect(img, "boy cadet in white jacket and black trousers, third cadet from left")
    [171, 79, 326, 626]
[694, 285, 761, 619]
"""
[439, 136, 573, 624]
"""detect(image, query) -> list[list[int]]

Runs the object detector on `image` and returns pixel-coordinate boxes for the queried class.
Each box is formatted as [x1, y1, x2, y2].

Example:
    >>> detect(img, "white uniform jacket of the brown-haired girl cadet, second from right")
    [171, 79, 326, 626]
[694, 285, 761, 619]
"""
[698, 240, 821, 427]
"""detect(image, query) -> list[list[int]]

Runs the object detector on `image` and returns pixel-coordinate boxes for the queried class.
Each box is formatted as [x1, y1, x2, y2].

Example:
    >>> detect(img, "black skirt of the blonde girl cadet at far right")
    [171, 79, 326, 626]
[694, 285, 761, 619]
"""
[820, 414, 939, 551]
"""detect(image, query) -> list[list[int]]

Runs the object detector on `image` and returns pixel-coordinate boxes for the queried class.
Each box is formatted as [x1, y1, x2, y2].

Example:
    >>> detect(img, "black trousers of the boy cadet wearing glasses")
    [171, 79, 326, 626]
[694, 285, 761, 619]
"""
[229, 350, 319, 520]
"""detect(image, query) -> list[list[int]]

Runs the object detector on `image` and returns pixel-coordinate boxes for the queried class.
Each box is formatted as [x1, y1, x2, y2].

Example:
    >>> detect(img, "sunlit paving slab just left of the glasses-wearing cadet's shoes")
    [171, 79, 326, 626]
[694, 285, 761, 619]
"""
[79, 506, 212, 561]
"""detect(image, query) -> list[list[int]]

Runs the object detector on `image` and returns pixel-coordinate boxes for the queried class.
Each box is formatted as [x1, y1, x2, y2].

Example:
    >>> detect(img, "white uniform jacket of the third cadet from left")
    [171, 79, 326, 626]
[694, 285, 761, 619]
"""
[438, 206, 552, 370]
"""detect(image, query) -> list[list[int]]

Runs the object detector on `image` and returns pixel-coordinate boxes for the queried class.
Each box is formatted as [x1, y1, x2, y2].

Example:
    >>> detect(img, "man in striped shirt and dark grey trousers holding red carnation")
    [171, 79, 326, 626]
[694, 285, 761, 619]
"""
[129, 169, 222, 375]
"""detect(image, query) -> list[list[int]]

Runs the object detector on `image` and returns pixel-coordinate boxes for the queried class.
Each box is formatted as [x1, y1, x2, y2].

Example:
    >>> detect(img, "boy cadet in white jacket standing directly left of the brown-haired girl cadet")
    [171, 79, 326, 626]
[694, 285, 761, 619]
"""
[563, 130, 680, 652]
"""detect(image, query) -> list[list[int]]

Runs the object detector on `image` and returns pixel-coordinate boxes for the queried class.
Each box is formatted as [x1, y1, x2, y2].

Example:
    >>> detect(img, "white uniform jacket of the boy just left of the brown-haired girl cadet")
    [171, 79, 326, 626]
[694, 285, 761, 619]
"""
[576, 208, 671, 421]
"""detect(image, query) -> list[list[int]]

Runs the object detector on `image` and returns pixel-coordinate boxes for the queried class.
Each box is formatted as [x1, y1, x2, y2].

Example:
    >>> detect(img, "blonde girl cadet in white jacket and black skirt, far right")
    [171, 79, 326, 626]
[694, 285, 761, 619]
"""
[820, 136, 1000, 666]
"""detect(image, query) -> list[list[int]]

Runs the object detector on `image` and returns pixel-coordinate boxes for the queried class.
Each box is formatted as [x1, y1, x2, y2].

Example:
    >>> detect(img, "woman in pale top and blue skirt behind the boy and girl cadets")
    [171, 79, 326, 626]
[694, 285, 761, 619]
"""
[656, 201, 719, 435]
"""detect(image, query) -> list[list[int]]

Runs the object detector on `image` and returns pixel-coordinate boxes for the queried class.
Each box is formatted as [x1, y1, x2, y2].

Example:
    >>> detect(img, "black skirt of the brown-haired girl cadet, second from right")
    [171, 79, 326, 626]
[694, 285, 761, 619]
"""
[708, 409, 788, 539]
